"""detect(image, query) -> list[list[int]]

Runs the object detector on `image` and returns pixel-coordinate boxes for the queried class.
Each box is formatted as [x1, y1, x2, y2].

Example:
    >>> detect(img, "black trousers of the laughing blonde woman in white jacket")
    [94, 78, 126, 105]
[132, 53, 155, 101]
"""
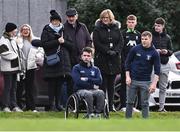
[17, 69, 35, 110]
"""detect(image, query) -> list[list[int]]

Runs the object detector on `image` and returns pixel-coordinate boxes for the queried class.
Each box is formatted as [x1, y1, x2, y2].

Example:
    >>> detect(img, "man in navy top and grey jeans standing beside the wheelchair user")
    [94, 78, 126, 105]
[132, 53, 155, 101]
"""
[125, 31, 160, 118]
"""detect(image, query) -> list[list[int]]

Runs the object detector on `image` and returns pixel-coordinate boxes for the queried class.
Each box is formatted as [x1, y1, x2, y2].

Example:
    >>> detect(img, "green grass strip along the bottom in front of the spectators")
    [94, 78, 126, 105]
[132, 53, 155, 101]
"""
[0, 112, 180, 131]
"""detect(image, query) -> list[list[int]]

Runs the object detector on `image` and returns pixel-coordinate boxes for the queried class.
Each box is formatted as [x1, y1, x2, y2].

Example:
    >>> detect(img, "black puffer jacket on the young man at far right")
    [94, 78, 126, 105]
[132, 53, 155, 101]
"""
[152, 30, 173, 64]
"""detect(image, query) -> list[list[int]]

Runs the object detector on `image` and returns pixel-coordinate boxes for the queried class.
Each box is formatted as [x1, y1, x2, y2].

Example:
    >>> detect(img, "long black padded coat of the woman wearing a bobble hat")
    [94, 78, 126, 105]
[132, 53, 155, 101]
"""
[41, 25, 72, 80]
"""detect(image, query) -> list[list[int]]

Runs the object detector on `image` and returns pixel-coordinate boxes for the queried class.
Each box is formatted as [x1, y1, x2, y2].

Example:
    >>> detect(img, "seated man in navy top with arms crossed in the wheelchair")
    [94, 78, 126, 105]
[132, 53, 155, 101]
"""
[72, 47, 105, 118]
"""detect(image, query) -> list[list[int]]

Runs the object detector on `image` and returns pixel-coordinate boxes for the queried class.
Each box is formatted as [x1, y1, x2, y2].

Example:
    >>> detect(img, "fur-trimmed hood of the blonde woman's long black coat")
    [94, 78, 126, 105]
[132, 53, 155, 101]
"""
[95, 19, 121, 29]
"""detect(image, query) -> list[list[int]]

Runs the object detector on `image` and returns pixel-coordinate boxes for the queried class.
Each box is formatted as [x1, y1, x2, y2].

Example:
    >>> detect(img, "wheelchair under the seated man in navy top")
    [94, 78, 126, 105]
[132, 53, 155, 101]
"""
[65, 93, 109, 119]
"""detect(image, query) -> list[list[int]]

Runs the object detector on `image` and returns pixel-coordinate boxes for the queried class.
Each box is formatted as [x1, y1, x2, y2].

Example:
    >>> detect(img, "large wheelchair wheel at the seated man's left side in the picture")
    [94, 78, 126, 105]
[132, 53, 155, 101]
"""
[65, 95, 79, 119]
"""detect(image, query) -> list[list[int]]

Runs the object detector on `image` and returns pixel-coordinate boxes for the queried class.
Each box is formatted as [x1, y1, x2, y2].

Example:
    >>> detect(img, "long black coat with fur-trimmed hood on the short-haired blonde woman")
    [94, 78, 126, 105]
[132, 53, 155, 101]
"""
[93, 20, 123, 75]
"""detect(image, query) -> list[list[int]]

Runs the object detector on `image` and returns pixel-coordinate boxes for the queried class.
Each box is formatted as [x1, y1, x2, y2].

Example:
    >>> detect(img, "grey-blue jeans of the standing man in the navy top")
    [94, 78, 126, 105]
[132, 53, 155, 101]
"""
[126, 80, 151, 118]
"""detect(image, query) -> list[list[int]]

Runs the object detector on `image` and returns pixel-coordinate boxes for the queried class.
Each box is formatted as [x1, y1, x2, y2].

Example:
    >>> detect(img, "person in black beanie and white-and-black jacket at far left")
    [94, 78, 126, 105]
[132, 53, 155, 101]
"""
[0, 23, 22, 112]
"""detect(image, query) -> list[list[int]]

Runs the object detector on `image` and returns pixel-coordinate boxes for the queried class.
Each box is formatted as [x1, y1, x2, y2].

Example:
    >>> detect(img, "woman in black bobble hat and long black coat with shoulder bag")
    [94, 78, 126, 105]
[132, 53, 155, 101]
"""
[41, 10, 72, 111]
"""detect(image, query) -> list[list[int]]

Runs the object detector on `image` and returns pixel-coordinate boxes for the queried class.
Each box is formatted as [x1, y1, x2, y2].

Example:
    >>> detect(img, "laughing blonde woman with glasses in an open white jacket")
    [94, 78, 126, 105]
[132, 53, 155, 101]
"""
[17, 24, 44, 112]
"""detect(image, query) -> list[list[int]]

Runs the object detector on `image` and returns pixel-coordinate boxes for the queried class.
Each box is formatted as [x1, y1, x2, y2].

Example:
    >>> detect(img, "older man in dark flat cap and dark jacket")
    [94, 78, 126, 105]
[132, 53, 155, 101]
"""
[64, 8, 92, 66]
